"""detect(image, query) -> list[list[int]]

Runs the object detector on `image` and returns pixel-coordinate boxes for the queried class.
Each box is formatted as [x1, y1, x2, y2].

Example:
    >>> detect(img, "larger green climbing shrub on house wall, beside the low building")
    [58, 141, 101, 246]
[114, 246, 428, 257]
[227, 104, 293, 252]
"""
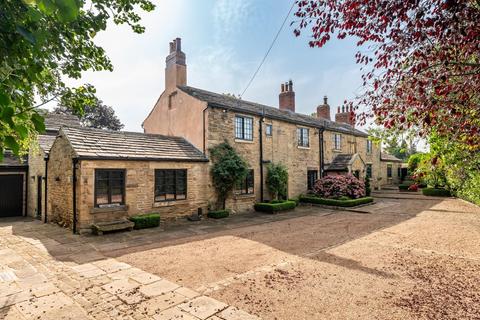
[209, 141, 248, 209]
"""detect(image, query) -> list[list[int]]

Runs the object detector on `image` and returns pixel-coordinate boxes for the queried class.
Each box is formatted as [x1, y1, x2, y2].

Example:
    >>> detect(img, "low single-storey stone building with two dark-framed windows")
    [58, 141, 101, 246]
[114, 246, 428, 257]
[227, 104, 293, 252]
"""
[47, 127, 208, 233]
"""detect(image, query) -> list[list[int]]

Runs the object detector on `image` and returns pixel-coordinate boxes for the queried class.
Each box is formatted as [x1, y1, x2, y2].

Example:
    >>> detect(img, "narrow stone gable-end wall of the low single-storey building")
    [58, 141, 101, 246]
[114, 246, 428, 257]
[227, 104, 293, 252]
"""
[47, 136, 74, 228]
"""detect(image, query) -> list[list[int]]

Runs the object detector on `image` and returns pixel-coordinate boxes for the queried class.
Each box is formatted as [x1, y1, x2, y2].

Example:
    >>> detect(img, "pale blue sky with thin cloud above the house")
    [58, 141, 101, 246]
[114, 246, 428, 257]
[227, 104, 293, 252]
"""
[66, 0, 361, 131]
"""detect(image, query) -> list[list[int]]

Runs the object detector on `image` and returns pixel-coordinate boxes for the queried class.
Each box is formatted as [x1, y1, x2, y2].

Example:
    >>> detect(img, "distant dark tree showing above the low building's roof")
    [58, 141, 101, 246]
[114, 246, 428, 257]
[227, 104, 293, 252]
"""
[53, 100, 124, 131]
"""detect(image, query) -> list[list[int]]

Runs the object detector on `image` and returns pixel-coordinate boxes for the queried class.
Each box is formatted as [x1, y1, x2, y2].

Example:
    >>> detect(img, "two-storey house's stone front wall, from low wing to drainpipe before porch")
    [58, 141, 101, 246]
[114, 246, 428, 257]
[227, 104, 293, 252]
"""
[207, 108, 320, 211]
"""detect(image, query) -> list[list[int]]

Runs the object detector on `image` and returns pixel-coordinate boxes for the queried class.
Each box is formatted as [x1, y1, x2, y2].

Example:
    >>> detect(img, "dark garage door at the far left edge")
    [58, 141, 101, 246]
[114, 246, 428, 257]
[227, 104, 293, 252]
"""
[0, 174, 23, 217]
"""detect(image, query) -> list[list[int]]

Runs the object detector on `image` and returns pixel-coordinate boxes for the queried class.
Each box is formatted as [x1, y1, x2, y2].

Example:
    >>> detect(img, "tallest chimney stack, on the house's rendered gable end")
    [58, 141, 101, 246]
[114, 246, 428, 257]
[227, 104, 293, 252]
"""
[165, 38, 187, 91]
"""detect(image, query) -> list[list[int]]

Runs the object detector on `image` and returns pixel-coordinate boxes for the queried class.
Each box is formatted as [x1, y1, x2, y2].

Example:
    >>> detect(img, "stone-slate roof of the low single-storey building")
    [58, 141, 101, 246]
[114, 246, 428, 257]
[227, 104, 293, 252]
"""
[60, 127, 208, 162]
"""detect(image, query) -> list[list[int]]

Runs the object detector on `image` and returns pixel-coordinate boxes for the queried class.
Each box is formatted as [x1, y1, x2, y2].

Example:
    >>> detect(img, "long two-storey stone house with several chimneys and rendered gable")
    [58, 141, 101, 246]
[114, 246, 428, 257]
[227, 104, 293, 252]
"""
[143, 38, 381, 211]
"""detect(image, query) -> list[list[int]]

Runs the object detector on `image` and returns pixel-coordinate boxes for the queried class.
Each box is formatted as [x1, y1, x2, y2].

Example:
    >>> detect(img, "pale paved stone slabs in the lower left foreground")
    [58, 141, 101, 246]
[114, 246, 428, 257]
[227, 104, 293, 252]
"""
[0, 220, 259, 320]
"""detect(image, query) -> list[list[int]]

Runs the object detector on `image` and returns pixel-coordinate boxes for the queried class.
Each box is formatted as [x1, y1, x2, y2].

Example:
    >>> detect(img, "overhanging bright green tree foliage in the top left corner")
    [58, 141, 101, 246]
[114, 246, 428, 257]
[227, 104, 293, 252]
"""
[0, 0, 154, 157]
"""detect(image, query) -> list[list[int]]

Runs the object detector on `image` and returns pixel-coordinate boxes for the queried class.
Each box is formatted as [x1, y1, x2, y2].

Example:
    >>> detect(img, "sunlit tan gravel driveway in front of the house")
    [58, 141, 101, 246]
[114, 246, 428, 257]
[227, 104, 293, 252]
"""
[112, 191, 480, 319]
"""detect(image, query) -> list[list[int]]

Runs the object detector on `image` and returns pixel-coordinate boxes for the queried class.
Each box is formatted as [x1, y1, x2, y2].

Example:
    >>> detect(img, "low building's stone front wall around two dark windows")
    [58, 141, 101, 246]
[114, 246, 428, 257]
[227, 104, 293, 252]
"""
[78, 160, 208, 232]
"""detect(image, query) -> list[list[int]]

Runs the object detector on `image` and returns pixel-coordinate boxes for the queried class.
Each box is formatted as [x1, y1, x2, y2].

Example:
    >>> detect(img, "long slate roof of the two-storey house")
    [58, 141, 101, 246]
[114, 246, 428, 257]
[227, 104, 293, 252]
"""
[178, 86, 368, 137]
